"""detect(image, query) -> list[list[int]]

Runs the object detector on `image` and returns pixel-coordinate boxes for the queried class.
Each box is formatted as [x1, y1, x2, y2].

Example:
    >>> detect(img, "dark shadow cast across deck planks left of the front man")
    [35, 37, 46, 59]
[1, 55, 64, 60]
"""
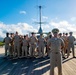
[0, 57, 50, 75]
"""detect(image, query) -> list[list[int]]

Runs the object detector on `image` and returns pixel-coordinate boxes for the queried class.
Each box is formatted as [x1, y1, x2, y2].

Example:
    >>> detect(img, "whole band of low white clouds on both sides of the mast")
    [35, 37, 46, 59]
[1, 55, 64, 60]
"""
[0, 20, 76, 37]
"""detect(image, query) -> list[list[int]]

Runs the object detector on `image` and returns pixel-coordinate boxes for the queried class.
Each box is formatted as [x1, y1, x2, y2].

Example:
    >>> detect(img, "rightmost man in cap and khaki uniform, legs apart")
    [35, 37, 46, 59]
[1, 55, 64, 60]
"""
[67, 32, 75, 58]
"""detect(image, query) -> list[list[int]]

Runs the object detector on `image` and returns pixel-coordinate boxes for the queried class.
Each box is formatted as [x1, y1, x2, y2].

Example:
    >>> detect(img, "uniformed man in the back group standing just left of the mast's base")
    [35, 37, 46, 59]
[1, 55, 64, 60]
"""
[29, 32, 37, 57]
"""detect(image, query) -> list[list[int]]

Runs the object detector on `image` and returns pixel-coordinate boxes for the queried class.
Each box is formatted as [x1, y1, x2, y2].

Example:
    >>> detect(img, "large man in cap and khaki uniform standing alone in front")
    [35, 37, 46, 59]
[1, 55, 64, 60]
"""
[47, 28, 64, 75]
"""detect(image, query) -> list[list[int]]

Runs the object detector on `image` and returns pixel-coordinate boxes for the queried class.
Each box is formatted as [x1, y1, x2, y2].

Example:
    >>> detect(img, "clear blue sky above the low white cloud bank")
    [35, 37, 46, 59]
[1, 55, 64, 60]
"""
[0, 0, 76, 24]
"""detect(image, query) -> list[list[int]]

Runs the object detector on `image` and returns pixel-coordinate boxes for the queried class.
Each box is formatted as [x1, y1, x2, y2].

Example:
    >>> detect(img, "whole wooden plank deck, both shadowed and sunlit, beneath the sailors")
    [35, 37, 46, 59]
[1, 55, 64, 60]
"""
[0, 47, 76, 75]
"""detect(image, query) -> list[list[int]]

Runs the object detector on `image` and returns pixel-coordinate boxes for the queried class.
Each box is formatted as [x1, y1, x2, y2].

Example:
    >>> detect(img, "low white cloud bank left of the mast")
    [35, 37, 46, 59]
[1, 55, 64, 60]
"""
[0, 22, 37, 37]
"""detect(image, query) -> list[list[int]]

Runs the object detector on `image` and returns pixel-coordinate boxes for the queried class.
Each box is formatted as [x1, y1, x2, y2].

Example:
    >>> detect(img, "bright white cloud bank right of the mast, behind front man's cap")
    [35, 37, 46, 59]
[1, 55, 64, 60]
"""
[38, 20, 76, 36]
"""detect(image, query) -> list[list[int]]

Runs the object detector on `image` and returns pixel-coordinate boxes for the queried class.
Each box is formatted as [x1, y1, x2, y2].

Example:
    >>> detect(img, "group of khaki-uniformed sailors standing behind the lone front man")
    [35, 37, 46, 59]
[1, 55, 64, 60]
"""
[3, 32, 75, 58]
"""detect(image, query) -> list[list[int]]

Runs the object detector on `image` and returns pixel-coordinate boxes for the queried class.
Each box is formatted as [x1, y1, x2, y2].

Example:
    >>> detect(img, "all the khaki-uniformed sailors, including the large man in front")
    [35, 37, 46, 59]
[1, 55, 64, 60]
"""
[4, 28, 75, 75]
